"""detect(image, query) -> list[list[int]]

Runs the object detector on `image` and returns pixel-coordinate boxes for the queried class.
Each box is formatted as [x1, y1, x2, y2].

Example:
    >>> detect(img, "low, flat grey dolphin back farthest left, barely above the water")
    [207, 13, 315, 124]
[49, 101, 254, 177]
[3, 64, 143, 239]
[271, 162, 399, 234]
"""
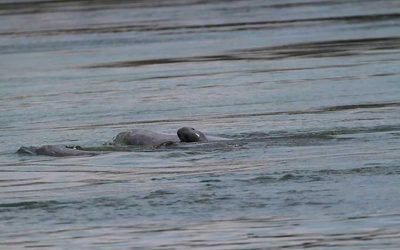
[17, 145, 101, 156]
